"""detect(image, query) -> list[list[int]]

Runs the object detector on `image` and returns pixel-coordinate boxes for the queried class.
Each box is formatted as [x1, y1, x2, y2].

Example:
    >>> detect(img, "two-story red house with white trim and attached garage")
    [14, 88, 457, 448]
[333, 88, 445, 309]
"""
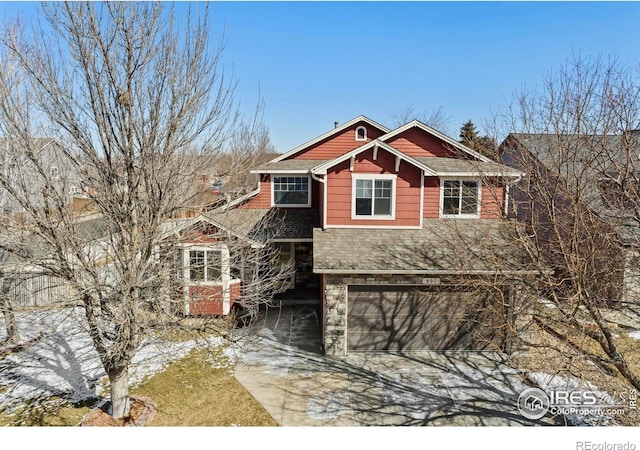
[178, 116, 527, 355]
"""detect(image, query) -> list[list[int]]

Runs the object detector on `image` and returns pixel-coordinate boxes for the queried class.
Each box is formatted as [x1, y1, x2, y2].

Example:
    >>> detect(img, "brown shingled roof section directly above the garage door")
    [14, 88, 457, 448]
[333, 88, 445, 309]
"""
[313, 219, 537, 275]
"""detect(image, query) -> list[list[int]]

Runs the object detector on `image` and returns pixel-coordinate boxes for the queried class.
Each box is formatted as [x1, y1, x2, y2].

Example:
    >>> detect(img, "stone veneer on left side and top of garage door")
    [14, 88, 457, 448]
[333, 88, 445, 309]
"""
[324, 274, 451, 356]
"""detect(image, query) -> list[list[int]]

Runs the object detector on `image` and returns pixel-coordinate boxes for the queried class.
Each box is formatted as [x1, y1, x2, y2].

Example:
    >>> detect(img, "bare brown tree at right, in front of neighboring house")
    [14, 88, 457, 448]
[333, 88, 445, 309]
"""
[500, 58, 640, 389]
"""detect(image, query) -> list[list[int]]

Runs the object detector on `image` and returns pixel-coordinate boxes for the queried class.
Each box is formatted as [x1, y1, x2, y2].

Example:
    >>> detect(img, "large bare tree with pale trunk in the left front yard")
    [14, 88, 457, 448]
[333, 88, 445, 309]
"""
[0, 2, 260, 418]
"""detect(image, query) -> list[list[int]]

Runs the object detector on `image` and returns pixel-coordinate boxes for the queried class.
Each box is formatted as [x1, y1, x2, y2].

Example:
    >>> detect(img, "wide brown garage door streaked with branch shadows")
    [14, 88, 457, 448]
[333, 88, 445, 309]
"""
[347, 286, 505, 352]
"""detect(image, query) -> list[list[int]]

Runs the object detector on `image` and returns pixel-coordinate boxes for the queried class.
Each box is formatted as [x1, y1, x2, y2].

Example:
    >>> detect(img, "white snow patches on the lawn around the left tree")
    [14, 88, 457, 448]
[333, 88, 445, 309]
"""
[0, 308, 229, 410]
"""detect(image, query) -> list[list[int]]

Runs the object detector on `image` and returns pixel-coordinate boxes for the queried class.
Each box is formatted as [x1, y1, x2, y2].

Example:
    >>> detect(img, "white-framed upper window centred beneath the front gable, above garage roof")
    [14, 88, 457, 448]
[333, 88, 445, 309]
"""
[351, 175, 396, 219]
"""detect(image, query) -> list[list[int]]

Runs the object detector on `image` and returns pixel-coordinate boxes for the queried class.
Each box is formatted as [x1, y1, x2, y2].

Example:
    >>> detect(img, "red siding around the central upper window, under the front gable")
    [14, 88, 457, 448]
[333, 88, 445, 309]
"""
[327, 149, 422, 227]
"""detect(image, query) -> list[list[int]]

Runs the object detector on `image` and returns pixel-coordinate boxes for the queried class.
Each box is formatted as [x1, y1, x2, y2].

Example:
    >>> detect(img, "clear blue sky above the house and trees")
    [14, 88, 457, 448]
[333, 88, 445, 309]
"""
[0, 2, 640, 152]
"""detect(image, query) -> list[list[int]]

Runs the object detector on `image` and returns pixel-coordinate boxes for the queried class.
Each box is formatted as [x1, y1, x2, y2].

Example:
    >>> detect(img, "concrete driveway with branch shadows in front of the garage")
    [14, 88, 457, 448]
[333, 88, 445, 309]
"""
[235, 306, 550, 426]
